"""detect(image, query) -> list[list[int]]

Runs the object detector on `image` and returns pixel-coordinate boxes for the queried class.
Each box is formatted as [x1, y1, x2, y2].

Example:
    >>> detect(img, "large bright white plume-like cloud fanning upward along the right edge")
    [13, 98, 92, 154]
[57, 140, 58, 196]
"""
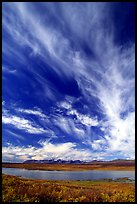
[70, 23, 135, 158]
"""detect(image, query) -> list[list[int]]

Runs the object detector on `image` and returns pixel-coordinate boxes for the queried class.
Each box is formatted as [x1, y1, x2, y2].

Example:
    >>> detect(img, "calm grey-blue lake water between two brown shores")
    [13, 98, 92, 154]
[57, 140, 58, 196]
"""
[2, 168, 135, 181]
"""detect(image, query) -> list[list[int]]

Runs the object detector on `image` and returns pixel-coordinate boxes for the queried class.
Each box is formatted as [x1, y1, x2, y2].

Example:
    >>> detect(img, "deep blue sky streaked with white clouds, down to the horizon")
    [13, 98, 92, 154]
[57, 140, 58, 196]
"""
[2, 2, 135, 162]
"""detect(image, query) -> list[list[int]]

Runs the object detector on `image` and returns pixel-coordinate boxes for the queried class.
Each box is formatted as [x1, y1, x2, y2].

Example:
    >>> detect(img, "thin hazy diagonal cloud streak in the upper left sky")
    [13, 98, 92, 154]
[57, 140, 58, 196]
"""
[3, 2, 75, 75]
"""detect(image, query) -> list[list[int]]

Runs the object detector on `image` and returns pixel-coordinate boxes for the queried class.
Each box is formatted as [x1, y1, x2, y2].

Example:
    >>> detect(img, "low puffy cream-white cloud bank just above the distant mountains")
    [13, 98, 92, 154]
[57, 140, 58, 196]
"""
[2, 141, 105, 161]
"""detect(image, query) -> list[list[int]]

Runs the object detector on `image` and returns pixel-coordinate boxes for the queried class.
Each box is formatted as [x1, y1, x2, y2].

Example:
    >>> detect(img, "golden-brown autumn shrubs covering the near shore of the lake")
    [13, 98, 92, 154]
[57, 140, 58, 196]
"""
[2, 175, 135, 202]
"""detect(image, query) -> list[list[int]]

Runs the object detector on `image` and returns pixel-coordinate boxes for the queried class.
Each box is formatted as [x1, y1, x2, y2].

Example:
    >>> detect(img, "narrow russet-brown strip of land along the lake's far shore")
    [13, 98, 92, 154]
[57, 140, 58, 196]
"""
[2, 160, 135, 171]
